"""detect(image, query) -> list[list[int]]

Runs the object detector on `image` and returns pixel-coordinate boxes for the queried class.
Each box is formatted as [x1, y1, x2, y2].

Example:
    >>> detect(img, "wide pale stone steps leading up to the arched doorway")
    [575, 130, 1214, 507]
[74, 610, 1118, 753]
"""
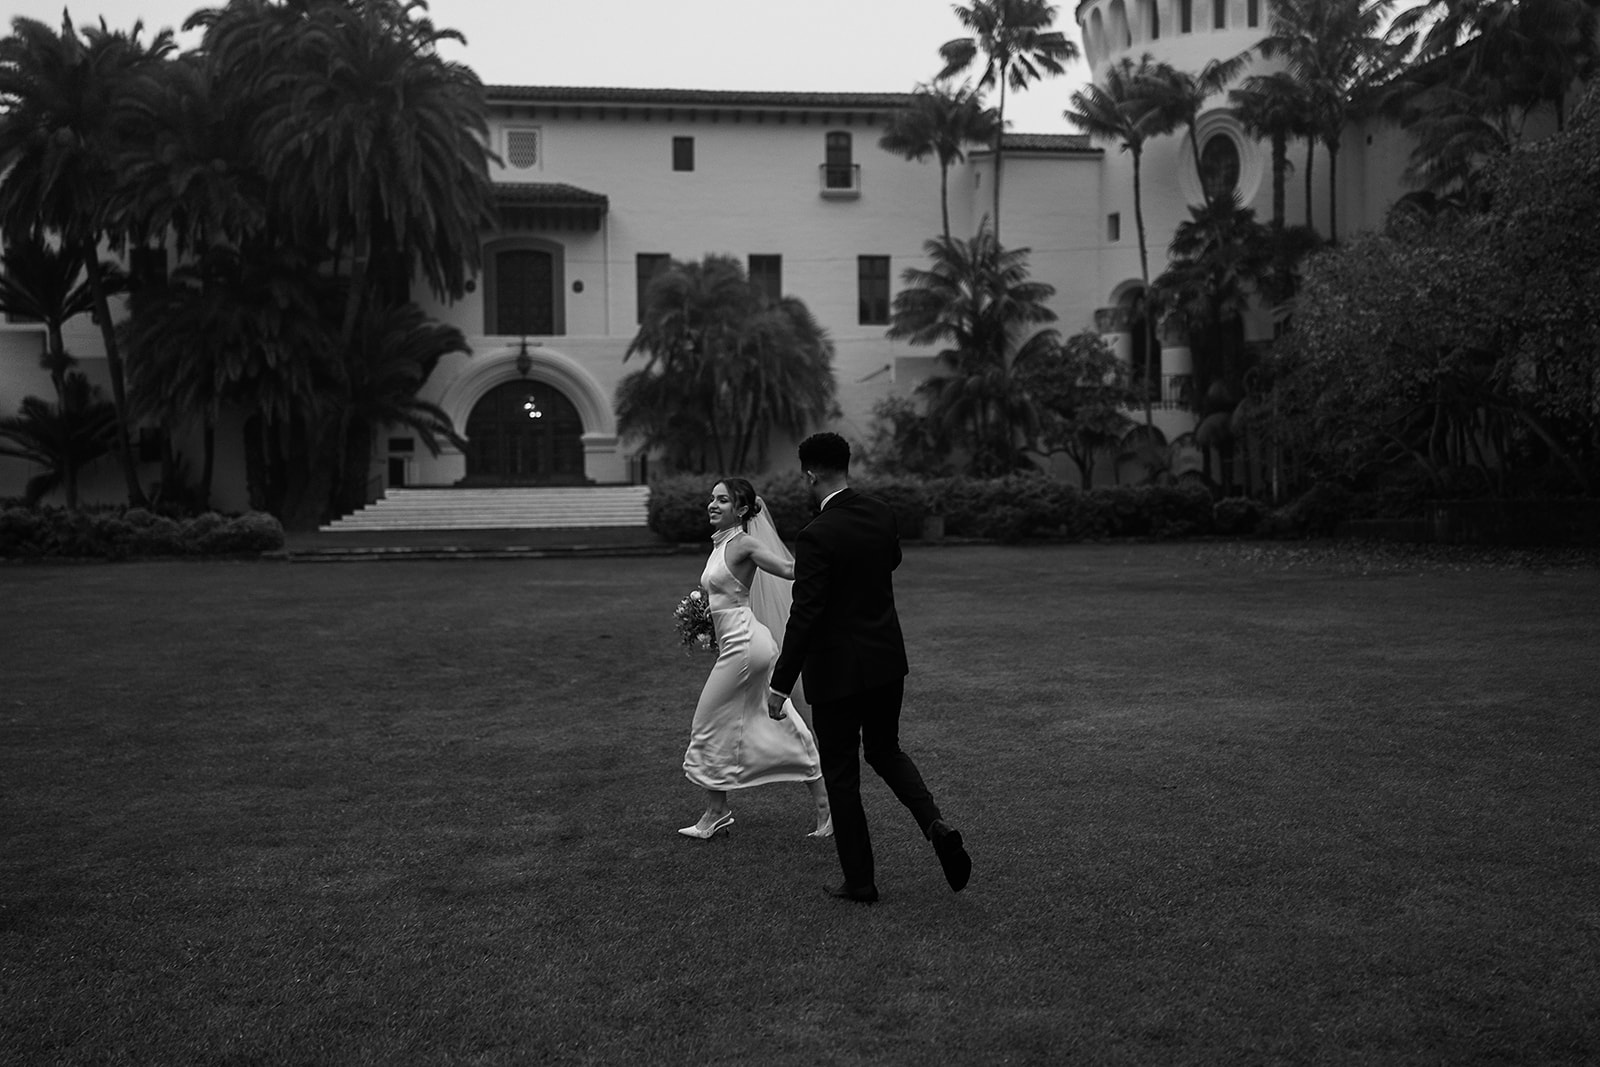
[318, 485, 650, 534]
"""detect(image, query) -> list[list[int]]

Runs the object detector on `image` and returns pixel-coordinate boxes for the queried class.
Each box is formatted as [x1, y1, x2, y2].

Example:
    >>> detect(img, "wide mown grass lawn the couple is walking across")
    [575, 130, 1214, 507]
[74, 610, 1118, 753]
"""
[0, 545, 1600, 1065]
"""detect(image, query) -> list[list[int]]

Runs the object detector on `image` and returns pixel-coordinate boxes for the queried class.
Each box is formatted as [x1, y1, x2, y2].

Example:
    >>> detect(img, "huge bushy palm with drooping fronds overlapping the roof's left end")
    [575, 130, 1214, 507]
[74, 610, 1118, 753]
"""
[200, 0, 493, 358]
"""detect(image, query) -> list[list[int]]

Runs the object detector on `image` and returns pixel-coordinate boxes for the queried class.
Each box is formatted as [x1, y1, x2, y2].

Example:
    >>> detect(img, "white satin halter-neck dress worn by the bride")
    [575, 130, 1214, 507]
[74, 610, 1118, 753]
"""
[683, 528, 822, 790]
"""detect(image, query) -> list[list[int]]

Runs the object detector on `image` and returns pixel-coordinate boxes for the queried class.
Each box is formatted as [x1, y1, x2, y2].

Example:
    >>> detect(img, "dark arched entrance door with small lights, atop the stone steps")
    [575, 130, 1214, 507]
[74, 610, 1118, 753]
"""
[462, 381, 587, 485]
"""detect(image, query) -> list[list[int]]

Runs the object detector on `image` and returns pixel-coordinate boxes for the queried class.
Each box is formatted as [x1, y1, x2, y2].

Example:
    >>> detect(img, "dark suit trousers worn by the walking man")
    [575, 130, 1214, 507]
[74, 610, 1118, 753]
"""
[811, 678, 939, 888]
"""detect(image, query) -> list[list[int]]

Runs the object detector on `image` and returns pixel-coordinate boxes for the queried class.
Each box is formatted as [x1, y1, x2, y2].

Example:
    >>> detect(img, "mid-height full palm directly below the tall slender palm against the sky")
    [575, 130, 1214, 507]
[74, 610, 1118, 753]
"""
[888, 227, 1061, 475]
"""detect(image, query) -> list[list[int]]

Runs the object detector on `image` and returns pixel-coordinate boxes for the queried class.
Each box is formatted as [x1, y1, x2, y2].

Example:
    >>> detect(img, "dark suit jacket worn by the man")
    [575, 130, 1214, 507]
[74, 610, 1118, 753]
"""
[773, 488, 907, 704]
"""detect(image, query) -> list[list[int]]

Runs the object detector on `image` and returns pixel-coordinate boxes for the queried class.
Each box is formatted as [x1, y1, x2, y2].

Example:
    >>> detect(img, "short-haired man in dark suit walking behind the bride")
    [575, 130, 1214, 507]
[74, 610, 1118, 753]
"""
[766, 434, 973, 904]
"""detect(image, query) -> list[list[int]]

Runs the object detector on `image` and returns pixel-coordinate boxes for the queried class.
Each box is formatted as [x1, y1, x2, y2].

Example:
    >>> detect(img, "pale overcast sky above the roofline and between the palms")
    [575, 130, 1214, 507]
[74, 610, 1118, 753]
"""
[0, 0, 1088, 133]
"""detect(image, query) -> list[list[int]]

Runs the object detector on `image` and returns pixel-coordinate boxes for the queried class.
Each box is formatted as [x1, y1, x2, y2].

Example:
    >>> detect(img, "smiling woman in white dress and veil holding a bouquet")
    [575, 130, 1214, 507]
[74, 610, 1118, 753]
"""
[678, 478, 834, 838]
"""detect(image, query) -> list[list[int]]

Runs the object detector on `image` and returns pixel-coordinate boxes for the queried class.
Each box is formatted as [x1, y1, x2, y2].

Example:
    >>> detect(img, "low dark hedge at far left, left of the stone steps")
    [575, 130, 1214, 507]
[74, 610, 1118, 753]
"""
[0, 507, 283, 560]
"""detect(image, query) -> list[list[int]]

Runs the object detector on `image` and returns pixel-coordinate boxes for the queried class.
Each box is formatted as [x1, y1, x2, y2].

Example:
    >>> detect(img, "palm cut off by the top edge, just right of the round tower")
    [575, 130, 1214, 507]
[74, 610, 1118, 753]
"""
[1258, 0, 1410, 242]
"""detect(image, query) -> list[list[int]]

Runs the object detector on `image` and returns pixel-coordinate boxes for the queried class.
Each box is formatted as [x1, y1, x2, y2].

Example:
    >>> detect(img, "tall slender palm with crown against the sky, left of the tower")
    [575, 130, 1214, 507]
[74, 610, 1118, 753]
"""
[939, 0, 1078, 242]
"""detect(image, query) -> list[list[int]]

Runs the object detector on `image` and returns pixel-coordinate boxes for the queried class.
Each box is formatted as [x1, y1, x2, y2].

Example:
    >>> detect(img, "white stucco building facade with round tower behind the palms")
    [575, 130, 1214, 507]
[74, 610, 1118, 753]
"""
[0, 7, 1427, 510]
